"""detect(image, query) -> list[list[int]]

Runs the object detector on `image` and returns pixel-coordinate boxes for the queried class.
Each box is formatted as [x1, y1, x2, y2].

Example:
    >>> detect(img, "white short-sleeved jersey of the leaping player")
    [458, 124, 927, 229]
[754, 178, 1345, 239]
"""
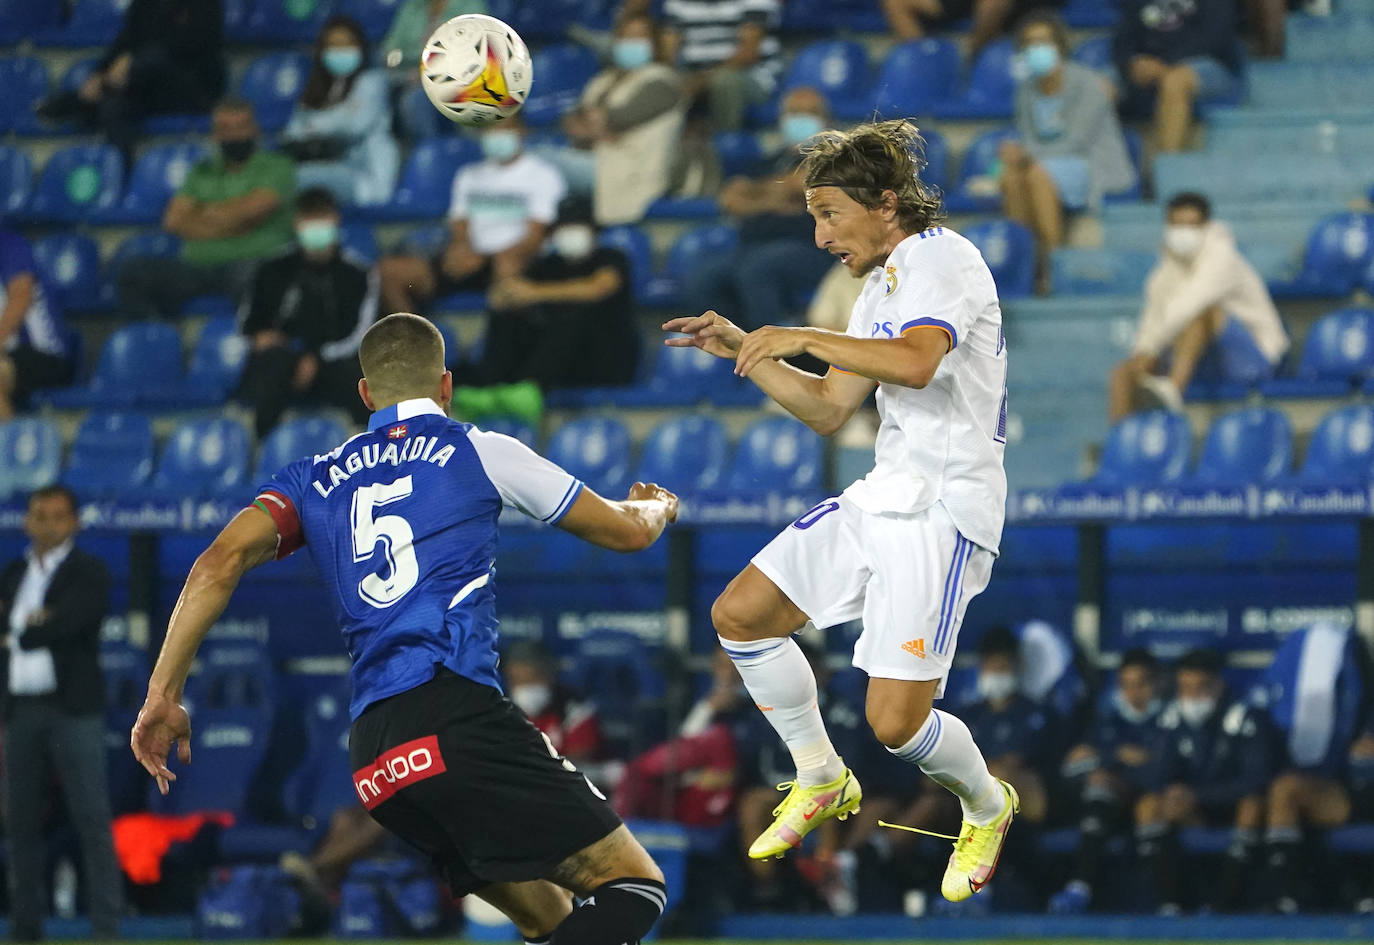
[845, 227, 1007, 554]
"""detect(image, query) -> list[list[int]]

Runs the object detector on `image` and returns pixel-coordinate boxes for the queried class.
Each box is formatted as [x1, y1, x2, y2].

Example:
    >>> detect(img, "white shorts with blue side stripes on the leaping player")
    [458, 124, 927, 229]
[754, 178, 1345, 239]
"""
[753, 496, 995, 698]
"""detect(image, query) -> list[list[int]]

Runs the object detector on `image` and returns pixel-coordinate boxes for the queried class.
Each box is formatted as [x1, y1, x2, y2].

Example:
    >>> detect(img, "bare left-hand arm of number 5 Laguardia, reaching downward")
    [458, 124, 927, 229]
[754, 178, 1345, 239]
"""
[129, 508, 278, 794]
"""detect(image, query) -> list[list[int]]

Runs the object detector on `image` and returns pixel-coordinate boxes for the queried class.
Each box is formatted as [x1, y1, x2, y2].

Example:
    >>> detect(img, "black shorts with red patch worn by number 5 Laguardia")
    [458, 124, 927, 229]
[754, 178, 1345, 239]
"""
[349, 669, 620, 896]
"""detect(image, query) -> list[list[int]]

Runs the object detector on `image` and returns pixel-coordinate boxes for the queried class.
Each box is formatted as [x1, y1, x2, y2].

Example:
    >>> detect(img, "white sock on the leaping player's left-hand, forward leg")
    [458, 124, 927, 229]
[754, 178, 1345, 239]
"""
[720, 636, 845, 787]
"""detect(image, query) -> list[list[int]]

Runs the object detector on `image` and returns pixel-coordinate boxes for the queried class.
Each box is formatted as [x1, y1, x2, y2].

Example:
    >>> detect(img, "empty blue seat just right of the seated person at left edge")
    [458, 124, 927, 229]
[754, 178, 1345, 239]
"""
[38, 321, 183, 407]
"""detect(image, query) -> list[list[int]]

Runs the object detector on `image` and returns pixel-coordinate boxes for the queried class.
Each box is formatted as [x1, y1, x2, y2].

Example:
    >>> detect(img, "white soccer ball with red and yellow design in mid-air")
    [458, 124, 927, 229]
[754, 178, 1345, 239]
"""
[420, 14, 534, 125]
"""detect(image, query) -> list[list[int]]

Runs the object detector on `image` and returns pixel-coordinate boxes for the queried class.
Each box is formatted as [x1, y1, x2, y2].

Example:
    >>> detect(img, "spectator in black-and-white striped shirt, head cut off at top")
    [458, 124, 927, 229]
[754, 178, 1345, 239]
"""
[664, 0, 782, 132]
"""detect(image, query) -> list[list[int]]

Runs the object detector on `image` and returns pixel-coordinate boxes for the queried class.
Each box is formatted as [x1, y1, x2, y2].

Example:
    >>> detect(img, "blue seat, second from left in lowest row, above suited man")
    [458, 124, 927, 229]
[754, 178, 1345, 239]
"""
[62, 411, 153, 499]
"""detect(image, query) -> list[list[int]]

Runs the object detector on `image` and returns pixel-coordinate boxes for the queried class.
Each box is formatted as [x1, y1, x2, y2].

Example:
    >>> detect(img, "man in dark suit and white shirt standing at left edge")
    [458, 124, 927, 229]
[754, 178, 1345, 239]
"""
[0, 486, 121, 942]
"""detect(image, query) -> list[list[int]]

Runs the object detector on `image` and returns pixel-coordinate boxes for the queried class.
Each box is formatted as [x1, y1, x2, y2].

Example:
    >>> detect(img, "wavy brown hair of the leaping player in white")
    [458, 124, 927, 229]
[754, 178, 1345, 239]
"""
[801, 118, 945, 234]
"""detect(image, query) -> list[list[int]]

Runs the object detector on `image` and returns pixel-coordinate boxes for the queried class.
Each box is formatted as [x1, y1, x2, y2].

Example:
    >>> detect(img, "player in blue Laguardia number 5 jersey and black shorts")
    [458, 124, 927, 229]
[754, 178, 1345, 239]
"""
[131, 313, 677, 945]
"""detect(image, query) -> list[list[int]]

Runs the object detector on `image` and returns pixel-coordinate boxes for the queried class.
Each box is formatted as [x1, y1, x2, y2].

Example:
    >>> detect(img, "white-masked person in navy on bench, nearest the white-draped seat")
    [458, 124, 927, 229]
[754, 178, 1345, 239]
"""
[1135, 650, 1274, 915]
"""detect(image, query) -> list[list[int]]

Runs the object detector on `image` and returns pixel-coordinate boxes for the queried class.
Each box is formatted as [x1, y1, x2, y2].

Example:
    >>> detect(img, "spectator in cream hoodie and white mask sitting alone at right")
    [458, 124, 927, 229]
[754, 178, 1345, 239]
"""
[1109, 192, 1289, 423]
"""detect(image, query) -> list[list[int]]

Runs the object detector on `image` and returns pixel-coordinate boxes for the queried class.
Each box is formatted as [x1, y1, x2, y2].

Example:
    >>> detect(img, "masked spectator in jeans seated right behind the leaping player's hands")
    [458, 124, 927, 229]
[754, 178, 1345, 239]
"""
[683, 87, 830, 331]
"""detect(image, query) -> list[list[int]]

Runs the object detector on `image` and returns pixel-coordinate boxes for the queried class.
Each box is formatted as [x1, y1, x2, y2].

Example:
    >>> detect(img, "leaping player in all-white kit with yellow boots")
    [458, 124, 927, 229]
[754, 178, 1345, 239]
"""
[664, 121, 1020, 901]
